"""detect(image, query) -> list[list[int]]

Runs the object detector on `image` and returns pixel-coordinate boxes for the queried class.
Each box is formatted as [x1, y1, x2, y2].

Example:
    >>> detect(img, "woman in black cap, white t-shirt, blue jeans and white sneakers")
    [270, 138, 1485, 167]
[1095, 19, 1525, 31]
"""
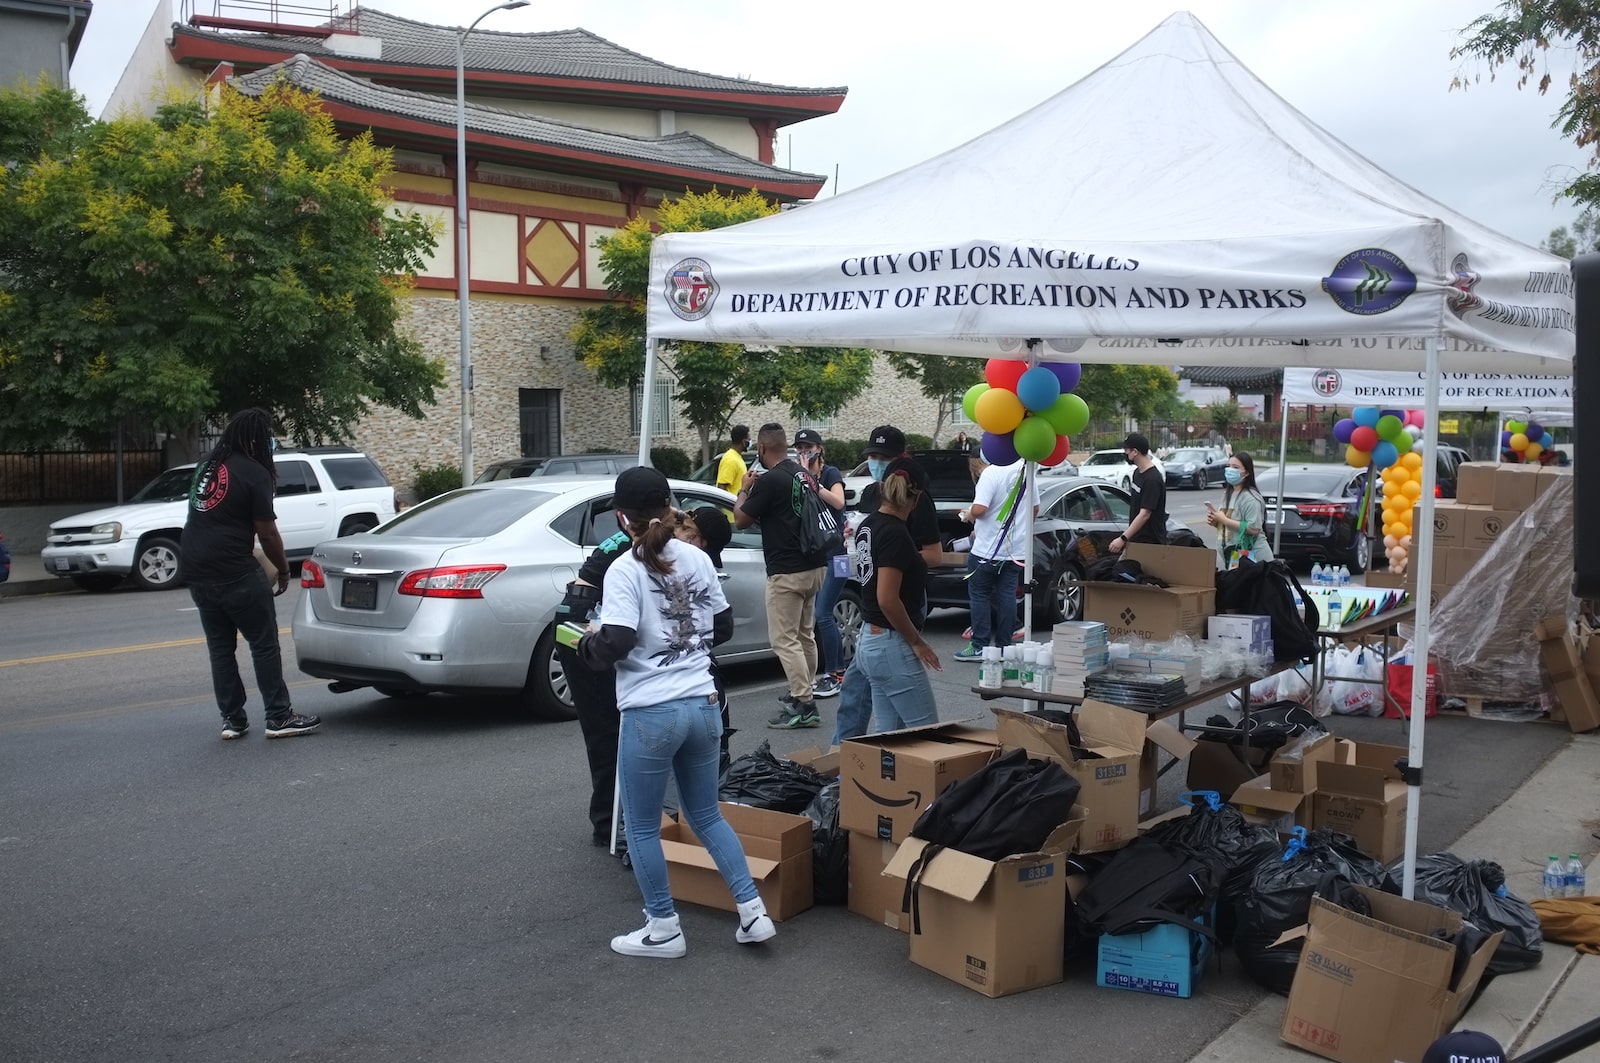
[578, 466, 778, 957]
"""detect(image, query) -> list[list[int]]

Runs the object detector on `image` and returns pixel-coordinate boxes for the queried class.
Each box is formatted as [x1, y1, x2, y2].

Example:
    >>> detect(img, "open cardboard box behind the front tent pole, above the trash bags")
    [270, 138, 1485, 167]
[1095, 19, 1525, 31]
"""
[1310, 740, 1410, 863]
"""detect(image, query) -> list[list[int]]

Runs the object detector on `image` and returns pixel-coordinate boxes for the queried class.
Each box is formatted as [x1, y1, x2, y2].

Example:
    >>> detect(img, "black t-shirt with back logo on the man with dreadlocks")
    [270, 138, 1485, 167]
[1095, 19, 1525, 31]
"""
[184, 455, 277, 583]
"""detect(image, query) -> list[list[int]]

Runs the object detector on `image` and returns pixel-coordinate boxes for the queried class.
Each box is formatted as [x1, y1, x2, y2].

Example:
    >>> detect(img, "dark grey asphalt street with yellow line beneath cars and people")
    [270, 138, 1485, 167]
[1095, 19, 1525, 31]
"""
[0, 505, 1566, 1063]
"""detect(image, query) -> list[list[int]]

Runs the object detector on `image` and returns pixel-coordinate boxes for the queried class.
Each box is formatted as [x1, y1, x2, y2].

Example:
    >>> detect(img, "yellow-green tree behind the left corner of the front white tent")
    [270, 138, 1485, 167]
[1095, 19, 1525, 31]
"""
[571, 189, 874, 461]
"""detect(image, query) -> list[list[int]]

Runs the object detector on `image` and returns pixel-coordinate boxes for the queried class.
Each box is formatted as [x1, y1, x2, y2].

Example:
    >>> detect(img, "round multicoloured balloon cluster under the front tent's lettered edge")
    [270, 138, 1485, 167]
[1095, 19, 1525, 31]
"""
[962, 359, 1090, 466]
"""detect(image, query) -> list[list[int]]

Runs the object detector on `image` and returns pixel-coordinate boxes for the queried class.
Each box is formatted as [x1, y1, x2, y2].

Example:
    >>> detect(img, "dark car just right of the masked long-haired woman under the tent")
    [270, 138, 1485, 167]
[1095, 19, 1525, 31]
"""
[1258, 464, 1376, 573]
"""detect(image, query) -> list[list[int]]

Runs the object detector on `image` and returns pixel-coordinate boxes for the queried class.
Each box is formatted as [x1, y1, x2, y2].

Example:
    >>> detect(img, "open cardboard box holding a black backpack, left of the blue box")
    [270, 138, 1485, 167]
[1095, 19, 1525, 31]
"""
[886, 808, 1083, 997]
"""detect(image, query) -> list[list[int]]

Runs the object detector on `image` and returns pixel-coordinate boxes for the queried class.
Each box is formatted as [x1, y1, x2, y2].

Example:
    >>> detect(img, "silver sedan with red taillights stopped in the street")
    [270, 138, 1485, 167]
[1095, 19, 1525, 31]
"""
[291, 477, 771, 719]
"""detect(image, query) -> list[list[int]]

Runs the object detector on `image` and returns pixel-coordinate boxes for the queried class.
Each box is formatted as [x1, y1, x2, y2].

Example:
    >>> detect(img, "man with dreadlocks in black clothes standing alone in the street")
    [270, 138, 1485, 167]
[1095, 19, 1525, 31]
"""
[182, 410, 322, 740]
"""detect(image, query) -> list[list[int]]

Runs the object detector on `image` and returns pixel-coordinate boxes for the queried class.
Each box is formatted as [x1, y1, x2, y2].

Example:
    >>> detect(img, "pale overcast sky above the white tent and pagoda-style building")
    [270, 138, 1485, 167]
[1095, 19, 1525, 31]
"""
[72, 0, 1589, 245]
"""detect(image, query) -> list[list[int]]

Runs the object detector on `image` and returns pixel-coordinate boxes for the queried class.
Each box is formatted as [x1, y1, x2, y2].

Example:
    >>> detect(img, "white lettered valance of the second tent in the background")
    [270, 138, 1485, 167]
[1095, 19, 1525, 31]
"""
[1283, 368, 1573, 415]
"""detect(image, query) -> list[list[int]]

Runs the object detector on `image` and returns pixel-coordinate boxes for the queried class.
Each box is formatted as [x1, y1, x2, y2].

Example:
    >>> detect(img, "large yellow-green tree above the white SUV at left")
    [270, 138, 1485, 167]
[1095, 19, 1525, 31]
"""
[0, 85, 443, 447]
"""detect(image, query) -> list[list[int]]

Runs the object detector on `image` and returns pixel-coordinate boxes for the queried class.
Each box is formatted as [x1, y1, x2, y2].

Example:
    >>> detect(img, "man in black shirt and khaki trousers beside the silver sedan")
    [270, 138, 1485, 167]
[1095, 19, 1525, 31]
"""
[733, 423, 827, 728]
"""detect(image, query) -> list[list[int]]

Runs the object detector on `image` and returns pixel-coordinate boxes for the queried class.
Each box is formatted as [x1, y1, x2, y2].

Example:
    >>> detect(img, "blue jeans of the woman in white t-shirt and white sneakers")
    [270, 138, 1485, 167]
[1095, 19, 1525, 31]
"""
[616, 695, 755, 919]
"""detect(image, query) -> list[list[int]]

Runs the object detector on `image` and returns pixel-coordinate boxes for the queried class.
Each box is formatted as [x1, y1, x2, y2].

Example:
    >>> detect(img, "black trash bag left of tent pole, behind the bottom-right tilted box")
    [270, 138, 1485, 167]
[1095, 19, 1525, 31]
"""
[1234, 828, 1400, 996]
